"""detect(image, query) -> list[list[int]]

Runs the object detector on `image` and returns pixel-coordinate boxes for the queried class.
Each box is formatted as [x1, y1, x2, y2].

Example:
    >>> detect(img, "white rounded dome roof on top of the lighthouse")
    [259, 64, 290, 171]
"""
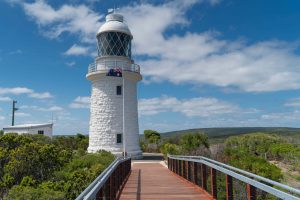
[97, 13, 132, 37]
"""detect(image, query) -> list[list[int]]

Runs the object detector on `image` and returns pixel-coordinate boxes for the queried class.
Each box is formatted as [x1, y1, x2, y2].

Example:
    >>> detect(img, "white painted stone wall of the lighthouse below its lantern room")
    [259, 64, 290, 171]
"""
[87, 12, 142, 158]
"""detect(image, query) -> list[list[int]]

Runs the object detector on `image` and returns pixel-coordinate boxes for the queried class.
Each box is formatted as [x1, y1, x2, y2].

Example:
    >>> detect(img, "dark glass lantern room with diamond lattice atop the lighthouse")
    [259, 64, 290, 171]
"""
[97, 32, 131, 58]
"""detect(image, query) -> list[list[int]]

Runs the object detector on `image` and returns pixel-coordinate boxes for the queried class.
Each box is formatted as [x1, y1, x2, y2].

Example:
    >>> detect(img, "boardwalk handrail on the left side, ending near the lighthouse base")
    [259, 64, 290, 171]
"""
[76, 157, 131, 200]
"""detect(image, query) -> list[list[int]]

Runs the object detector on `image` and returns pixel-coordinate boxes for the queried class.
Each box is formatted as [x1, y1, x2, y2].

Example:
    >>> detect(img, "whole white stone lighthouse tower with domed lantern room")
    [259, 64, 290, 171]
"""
[86, 13, 142, 158]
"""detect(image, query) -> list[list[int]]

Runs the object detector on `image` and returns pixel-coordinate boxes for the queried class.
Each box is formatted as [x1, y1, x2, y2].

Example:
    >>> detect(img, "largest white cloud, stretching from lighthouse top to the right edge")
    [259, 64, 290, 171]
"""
[121, 1, 300, 92]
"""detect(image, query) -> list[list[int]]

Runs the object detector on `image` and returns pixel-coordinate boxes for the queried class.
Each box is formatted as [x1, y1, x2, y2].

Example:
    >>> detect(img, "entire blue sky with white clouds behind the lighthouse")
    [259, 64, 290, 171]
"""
[0, 0, 300, 134]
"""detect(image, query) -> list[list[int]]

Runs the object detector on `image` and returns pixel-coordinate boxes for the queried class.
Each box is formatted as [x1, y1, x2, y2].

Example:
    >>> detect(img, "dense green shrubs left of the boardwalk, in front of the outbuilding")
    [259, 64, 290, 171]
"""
[0, 134, 115, 200]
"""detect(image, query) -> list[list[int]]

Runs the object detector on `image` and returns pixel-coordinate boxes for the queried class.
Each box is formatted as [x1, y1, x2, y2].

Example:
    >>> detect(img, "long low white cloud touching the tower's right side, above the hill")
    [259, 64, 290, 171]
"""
[139, 96, 241, 117]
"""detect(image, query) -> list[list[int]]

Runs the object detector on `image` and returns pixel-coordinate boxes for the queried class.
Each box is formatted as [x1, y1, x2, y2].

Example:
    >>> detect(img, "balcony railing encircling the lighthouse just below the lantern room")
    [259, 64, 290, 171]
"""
[88, 61, 140, 73]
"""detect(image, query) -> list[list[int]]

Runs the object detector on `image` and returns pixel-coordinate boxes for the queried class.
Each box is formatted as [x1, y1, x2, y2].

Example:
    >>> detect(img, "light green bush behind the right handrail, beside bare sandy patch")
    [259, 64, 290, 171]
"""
[225, 133, 283, 181]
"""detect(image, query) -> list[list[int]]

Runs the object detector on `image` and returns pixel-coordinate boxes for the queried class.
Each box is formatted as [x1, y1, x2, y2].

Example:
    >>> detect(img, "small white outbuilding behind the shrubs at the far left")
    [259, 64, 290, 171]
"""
[3, 123, 53, 137]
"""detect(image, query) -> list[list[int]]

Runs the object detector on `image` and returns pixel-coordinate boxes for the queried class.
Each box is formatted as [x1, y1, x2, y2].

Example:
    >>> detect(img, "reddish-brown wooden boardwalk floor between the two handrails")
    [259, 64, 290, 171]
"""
[120, 162, 212, 200]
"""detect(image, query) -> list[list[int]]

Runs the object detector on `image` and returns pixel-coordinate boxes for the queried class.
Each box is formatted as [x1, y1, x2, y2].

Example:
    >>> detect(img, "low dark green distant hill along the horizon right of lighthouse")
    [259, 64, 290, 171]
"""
[161, 127, 300, 139]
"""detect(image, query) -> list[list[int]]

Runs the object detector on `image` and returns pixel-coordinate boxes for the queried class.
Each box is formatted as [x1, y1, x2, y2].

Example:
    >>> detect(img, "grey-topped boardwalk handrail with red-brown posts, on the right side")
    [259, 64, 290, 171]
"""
[168, 155, 300, 200]
